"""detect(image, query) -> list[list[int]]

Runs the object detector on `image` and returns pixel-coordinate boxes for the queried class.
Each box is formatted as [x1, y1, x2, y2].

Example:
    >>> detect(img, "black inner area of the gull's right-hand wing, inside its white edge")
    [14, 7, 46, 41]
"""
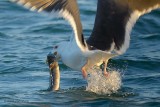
[87, 0, 131, 51]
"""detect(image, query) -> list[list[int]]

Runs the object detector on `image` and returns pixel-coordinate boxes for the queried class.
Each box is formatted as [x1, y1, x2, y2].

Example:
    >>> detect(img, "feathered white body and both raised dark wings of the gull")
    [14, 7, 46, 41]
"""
[12, 0, 160, 76]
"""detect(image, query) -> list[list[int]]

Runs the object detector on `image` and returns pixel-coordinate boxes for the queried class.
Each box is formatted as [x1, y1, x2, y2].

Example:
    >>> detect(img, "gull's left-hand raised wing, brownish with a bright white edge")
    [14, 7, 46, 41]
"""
[11, 0, 85, 49]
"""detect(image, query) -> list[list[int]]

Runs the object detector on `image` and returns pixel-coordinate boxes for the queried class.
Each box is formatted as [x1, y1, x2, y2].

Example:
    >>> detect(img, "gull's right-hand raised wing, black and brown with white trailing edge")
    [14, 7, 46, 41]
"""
[87, 0, 160, 54]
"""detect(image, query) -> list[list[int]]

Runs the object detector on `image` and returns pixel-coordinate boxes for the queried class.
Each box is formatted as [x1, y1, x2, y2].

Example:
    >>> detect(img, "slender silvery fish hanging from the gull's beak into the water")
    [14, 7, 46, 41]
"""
[47, 52, 60, 91]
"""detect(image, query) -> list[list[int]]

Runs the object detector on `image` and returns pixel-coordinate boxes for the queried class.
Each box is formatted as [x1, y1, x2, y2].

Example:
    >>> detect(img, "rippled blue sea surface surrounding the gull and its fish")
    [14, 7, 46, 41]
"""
[0, 0, 160, 107]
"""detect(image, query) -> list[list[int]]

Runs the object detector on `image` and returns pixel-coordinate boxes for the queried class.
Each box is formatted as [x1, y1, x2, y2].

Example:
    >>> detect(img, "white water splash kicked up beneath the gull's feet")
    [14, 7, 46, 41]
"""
[86, 68, 122, 94]
